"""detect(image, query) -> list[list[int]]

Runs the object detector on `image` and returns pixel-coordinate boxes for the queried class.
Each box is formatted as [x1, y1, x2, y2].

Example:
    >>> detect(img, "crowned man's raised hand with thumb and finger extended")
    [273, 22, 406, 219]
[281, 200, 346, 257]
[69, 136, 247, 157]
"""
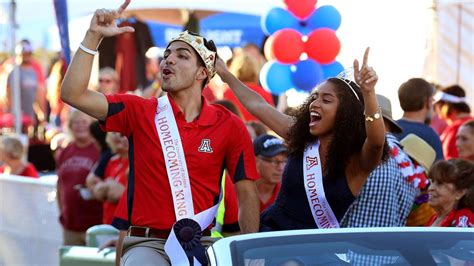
[89, 0, 135, 38]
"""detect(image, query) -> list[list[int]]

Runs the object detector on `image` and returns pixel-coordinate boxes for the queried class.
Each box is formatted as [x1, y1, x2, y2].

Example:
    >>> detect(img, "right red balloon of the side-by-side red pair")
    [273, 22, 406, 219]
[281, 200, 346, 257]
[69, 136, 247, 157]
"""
[305, 28, 341, 64]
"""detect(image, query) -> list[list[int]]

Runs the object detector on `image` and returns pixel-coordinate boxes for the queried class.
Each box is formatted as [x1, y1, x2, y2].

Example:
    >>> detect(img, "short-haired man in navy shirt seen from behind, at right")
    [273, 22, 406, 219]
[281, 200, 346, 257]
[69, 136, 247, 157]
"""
[395, 78, 443, 160]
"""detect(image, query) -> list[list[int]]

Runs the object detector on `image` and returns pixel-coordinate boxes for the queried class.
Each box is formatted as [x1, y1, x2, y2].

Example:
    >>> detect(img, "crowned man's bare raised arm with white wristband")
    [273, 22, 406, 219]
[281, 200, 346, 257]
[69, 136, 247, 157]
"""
[61, 0, 133, 120]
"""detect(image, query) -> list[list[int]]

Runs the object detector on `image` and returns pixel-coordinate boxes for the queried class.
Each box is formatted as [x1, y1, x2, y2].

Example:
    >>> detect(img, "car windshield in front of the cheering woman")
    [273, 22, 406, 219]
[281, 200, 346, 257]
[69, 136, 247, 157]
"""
[231, 232, 474, 266]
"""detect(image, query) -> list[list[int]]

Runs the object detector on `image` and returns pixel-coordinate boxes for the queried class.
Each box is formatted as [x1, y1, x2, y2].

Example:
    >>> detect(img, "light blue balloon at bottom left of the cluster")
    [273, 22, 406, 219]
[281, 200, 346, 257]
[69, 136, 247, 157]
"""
[260, 60, 295, 95]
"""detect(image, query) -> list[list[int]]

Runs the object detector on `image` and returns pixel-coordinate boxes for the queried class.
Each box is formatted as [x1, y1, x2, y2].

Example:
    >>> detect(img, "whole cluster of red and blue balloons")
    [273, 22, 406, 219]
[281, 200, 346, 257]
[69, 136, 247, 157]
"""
[260, 0, 344, 95]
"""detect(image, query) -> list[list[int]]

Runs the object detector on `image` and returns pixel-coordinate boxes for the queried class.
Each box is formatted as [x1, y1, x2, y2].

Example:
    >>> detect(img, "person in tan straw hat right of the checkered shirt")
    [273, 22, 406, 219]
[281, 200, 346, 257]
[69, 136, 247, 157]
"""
[400, 134, 436, 226]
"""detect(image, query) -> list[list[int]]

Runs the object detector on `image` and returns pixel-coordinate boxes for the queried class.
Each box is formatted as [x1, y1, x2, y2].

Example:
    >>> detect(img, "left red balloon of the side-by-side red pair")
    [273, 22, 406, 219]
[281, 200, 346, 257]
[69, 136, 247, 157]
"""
[271, 29, 304, 64]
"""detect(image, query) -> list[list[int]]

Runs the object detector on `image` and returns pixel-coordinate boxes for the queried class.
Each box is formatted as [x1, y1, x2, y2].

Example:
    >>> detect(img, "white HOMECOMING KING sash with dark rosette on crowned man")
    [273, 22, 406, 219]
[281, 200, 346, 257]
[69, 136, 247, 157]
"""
[155, 96, 222, 265]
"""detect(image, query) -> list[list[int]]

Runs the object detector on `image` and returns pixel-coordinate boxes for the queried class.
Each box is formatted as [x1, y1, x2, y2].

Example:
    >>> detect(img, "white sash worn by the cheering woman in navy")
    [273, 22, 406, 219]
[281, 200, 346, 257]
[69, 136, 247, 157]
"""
[303, 140, 339, 228]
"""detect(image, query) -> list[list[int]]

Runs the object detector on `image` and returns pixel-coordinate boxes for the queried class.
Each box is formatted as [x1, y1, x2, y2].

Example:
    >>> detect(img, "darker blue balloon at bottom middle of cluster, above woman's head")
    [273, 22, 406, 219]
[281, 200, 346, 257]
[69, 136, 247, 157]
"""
[291, 59, 324, 92]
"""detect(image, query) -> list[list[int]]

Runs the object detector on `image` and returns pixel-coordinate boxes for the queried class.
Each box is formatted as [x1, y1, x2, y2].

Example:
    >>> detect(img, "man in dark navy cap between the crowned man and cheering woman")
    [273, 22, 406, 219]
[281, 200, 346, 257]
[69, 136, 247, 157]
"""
[253, 134, 287, 212]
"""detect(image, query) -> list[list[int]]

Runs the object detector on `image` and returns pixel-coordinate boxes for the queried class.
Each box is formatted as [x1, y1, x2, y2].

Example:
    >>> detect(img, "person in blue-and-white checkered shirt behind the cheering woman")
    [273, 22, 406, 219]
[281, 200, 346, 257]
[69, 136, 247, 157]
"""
[341, 95, 418, 227]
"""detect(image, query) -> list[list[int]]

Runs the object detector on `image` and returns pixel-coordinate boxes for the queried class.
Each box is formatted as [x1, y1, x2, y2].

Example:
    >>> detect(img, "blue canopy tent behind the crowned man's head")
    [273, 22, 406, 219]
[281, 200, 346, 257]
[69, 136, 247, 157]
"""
[146, 12, 265, 48]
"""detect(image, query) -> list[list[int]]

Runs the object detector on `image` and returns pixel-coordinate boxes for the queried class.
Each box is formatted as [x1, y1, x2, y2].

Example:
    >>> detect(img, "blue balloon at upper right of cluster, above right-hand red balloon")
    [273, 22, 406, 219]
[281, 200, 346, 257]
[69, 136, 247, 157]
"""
[307, 6, 341, 30]
